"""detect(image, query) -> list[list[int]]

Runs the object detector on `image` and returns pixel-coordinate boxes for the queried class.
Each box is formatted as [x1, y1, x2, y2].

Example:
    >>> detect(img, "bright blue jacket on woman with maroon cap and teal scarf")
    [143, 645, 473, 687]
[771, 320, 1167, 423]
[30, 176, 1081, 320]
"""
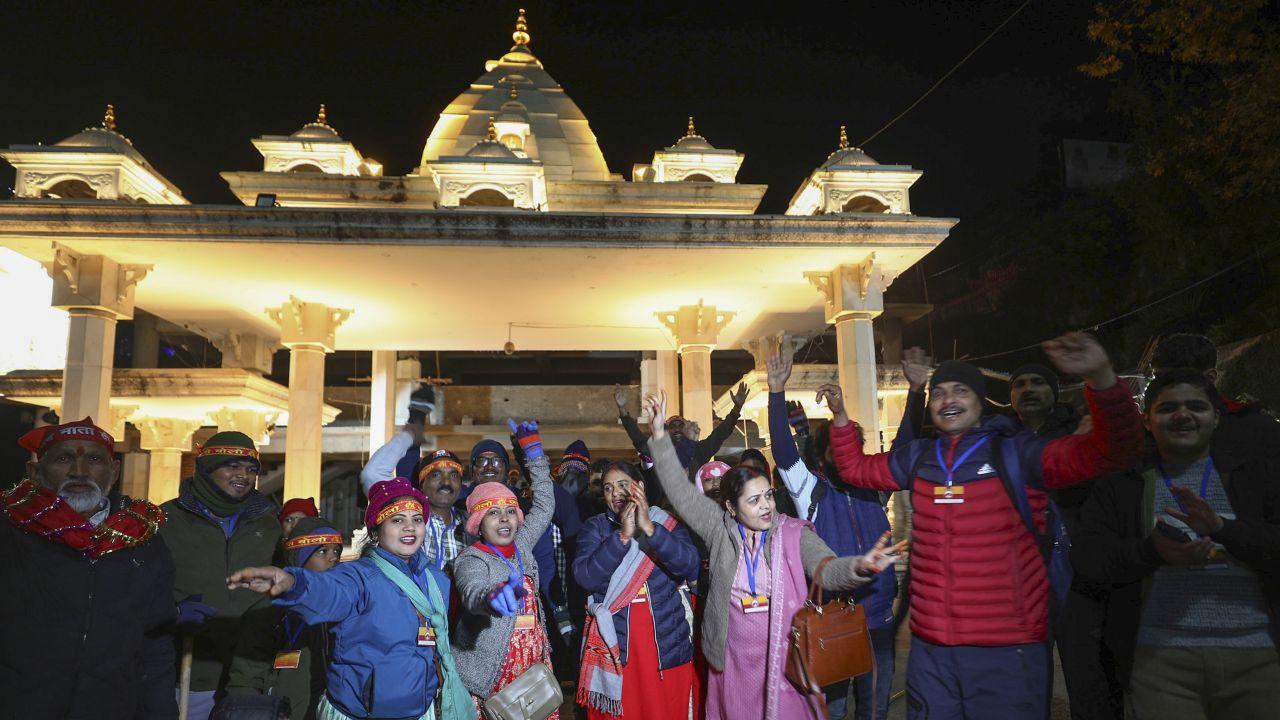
[274, 548, 449, 717]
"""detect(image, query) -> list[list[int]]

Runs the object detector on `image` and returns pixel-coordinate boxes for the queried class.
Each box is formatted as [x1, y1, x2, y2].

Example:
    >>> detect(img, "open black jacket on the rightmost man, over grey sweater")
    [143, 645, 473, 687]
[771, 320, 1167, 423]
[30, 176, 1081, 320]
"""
[1071, 446, 1280, 676]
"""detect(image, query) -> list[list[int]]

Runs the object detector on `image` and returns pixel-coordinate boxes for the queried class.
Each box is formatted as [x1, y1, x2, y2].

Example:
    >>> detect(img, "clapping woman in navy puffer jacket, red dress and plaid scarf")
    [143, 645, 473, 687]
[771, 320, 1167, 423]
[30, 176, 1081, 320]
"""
[573, 462, 701, 720]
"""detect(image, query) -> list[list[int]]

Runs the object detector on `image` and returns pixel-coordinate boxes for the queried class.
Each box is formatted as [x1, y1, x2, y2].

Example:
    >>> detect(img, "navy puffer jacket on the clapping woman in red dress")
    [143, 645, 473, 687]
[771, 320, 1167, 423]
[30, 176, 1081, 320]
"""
[573, 510, 701, 670]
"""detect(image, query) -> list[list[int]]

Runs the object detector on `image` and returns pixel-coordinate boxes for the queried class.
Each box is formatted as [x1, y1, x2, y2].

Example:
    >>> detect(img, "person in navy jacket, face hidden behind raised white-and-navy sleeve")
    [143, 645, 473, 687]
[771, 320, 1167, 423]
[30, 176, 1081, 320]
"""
[768, 355, 897, 720]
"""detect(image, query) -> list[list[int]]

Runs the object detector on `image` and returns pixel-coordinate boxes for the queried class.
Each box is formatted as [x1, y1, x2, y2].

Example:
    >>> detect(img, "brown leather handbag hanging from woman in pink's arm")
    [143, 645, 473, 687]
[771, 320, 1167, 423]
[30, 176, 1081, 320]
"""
[786, 557, 876, 717]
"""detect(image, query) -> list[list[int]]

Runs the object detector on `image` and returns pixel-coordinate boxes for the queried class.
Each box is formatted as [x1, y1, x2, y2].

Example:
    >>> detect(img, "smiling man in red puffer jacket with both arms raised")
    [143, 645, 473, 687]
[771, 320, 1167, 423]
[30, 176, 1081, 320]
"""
[818, 334, 1143, 720]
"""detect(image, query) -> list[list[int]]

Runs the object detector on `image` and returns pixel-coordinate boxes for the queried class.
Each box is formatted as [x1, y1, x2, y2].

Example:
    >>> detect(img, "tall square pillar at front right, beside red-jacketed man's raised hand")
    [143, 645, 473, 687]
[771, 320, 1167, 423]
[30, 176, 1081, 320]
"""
[805, 252, 890, 452]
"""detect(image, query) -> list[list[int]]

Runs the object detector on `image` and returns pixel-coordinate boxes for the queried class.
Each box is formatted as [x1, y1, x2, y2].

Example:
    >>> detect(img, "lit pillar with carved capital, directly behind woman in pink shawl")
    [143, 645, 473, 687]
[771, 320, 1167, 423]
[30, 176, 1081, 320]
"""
[655, 300, 733, 433]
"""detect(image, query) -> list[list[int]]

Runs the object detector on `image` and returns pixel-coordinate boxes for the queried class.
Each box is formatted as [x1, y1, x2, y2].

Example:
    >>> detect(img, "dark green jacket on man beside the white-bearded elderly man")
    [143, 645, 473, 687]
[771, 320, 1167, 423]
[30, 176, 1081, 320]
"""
[160, 478, 280, 692]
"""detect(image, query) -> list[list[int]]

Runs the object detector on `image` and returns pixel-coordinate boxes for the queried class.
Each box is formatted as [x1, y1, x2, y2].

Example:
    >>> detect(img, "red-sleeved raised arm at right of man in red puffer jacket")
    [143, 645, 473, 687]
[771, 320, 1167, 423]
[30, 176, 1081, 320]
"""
[1027, 333, 1143, 488]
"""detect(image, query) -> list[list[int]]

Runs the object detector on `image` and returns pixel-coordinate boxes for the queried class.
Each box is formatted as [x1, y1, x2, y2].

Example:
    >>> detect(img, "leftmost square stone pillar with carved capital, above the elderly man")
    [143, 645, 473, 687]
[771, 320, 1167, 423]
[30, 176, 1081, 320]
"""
[45, 245, 151, 421]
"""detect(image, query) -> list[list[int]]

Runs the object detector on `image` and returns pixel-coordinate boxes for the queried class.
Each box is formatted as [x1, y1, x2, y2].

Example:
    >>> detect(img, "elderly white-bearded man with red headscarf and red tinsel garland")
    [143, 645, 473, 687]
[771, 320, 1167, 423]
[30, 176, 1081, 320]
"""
[0, 418, 178, 720]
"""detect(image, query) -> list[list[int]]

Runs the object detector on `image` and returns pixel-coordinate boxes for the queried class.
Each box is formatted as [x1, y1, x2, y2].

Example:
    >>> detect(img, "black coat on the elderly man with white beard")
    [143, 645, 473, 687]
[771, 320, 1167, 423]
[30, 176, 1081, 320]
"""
[0, 503, 178, 720]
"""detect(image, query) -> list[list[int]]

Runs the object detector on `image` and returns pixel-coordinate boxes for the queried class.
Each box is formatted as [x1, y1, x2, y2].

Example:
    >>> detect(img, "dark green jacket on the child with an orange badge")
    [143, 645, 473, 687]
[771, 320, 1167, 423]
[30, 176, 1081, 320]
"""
[227, 597, 332, 720]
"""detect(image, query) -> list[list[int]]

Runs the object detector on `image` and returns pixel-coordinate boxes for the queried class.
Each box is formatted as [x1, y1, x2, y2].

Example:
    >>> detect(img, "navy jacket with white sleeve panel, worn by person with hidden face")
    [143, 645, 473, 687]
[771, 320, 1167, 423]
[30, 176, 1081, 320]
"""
[769, 392, 897, 629]
